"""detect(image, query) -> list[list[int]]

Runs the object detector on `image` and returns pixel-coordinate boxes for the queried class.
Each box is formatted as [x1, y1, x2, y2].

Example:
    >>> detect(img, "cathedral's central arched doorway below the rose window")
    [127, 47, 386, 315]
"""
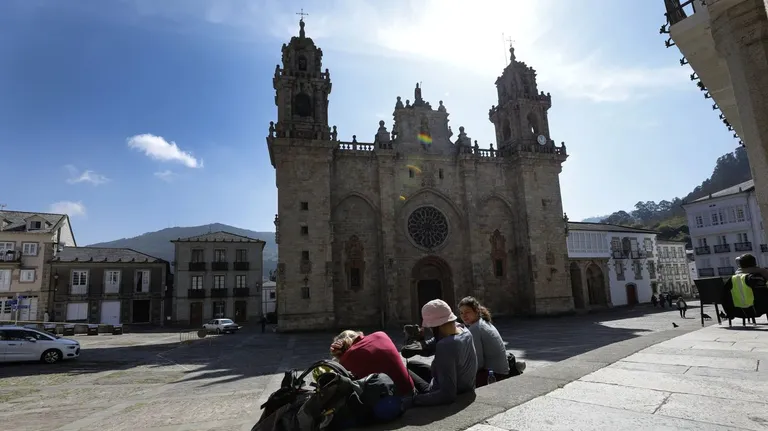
[411, 256, 456, 324]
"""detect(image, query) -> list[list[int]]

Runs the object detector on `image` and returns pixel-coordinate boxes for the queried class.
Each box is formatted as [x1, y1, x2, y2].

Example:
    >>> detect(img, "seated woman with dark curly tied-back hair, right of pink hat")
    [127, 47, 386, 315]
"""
[459, 296, 525, 388]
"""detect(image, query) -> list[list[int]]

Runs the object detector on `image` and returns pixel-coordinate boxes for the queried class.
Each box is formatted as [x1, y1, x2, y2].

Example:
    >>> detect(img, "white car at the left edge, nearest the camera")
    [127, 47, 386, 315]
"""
[0, 326, 80, 364]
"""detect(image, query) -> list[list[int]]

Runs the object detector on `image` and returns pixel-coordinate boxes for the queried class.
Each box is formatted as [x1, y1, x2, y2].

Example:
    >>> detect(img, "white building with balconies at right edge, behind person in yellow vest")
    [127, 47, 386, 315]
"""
[683, 180, 768, 278]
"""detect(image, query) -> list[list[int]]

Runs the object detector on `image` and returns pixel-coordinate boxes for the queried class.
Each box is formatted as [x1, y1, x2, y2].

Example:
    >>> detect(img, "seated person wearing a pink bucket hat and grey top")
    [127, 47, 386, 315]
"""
[403, 299, 477, 408]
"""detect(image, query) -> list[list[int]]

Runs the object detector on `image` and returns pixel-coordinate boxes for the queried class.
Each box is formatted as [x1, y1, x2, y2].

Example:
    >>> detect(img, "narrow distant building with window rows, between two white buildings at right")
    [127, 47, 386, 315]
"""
[654, 240, 693, 296]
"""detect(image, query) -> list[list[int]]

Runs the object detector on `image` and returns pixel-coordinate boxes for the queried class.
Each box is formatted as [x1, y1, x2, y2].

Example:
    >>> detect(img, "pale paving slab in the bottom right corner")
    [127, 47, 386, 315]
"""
[658, 394, 768, 431]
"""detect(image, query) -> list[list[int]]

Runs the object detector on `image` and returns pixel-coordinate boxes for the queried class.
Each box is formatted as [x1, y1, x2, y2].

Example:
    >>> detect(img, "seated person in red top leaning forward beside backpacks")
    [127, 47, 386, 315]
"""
[331, 331, 414, 396]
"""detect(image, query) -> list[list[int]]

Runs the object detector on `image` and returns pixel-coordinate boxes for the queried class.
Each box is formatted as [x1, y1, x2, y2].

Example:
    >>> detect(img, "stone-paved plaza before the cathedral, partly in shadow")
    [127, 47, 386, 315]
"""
[0, 304, 736, 431]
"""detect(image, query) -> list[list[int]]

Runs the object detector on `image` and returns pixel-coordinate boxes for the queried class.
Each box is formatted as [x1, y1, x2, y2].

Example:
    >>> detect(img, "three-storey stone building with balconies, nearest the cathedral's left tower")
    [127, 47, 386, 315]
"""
[171, 232, 266, 326]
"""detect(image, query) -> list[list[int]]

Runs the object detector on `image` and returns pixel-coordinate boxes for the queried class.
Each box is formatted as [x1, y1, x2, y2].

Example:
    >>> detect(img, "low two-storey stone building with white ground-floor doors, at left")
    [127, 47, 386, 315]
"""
[49, 247, 173, 325]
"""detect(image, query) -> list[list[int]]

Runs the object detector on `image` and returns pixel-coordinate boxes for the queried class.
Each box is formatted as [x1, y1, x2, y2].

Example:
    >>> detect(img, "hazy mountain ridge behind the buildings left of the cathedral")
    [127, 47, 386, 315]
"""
[90, 223, 277, 277]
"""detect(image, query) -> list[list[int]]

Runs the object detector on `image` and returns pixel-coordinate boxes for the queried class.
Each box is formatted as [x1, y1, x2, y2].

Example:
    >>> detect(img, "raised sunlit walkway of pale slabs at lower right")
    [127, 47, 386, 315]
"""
[468, 324, 768, 431]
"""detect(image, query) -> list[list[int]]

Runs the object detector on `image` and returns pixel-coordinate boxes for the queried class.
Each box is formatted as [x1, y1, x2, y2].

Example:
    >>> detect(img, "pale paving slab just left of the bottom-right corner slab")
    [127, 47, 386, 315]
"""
[547, 381, 670, 413]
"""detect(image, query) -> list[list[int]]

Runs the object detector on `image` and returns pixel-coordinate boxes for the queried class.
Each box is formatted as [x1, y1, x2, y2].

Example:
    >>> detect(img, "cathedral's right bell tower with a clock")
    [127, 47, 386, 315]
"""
[488, 47, 574, 314]
